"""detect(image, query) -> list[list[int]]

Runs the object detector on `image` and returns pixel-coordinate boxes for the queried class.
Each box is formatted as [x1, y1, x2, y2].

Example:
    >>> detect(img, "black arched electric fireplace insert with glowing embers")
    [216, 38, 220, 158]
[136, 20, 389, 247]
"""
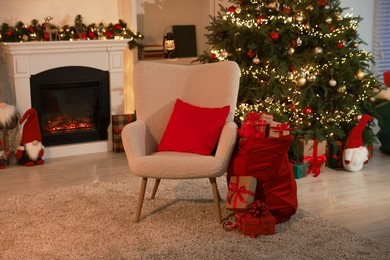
[30, 66, 110, 146]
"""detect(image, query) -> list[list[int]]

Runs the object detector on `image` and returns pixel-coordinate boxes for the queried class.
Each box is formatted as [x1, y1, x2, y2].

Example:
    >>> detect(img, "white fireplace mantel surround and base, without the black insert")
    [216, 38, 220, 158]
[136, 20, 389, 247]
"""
[2, 40, 128, 158]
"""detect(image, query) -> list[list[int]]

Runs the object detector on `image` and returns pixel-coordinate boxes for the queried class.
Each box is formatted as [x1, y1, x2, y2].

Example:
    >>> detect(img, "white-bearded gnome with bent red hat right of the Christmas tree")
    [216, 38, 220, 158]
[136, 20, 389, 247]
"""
[343, 114, 373, 172]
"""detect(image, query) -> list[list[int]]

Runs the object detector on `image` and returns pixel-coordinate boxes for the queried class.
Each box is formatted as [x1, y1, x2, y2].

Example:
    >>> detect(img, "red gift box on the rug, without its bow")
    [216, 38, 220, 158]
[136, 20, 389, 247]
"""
[235, 212, 276, 238]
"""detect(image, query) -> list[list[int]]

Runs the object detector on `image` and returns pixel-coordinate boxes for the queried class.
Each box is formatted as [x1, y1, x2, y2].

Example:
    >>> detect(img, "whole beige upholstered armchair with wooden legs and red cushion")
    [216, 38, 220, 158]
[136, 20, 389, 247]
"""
[122, 61, 240, 222]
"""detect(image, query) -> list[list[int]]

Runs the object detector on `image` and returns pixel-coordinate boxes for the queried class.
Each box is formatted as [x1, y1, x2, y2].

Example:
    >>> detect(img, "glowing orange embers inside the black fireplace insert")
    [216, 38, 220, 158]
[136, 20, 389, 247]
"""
[44, 115, 95, 134]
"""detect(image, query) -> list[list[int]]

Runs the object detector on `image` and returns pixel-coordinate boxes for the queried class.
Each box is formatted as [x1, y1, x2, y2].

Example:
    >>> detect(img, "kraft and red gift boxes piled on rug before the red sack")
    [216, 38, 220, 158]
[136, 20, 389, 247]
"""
[223, 176, 276, 238]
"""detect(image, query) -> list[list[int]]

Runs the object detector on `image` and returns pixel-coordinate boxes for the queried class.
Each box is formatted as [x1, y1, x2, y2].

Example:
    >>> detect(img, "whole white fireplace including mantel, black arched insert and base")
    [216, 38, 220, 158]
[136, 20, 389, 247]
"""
[0, 40, 131, 158]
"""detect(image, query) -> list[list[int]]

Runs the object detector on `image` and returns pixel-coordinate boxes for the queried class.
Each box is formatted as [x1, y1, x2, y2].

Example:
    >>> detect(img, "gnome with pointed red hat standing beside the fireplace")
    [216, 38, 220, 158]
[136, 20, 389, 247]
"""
[16, 108, 44, 166]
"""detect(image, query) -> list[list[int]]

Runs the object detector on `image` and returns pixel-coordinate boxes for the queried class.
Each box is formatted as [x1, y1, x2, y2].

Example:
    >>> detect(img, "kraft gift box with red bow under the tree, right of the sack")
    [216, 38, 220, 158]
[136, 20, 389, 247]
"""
[299, 139, 327, 177]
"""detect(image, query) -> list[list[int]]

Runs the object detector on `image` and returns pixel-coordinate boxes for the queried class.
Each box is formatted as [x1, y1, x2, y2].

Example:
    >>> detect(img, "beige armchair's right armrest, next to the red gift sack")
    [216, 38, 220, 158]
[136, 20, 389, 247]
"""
[215, 121, 237, 159]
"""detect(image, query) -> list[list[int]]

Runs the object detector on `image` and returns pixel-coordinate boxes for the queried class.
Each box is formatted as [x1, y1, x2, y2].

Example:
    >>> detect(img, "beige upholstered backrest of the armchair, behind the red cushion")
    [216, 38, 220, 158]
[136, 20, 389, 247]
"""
[134, 61, 241, 153]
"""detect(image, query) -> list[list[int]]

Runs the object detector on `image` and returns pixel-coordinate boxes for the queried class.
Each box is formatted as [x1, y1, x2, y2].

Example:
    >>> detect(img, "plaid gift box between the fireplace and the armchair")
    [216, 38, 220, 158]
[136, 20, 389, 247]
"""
[112, 114, 136, 153]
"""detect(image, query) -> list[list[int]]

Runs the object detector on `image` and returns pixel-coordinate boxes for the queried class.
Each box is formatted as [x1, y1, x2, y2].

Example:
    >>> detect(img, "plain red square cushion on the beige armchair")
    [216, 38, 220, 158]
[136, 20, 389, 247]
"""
[157, 99, 230, 155]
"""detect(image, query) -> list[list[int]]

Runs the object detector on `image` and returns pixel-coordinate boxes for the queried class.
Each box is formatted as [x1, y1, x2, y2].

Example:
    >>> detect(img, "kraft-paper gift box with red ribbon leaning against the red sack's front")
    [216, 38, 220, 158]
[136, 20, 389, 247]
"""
[226, 176, 257, 210]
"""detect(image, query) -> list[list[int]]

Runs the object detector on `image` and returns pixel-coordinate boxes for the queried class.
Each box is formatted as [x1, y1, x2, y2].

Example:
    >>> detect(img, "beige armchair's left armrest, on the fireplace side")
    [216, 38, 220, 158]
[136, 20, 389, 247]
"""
[121, 120, 146, 158]
